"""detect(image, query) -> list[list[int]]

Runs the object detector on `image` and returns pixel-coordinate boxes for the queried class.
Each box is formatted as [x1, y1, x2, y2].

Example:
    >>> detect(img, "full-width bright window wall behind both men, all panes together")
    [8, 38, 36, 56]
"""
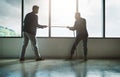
[0, 0, 120, 38]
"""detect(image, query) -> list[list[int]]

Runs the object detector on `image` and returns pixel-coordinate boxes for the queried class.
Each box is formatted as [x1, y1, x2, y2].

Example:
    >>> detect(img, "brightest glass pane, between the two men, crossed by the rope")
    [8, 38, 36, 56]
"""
[51, 0, 76, 37]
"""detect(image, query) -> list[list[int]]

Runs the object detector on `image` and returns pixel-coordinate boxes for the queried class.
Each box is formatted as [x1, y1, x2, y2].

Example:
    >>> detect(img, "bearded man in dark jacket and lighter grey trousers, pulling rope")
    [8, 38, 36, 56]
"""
[20, 5, 47, 61]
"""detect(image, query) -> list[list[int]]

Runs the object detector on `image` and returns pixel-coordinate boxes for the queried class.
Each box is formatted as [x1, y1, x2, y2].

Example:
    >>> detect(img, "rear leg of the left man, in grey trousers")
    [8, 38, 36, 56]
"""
[20, 32, 29, 61]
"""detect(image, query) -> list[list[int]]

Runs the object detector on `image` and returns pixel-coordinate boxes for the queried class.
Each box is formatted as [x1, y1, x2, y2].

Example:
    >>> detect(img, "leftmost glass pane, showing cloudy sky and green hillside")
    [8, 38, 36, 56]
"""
[0, 0, 22, 37]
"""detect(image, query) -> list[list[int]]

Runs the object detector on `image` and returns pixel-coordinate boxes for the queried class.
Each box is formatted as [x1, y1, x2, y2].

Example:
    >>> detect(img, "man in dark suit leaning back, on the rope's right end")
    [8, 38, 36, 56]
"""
[68, 12, 88, 61]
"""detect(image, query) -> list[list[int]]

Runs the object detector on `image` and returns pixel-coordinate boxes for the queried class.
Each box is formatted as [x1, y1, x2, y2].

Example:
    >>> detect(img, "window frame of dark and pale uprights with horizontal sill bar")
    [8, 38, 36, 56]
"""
[0, 0, 120, 39]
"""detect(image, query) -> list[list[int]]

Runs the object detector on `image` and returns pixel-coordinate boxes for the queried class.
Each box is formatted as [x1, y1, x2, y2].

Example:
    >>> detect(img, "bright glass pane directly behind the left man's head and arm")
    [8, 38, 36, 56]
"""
[24, 0, 49, 37]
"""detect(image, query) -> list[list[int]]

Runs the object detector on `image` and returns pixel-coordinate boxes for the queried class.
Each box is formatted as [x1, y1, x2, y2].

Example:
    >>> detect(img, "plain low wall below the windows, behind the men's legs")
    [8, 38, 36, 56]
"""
[0, 38, 120, 58]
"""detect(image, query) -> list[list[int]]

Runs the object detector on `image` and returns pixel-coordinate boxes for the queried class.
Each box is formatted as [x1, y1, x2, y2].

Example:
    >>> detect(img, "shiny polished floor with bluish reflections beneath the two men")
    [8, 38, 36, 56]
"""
[0, 59, 120, 77]
